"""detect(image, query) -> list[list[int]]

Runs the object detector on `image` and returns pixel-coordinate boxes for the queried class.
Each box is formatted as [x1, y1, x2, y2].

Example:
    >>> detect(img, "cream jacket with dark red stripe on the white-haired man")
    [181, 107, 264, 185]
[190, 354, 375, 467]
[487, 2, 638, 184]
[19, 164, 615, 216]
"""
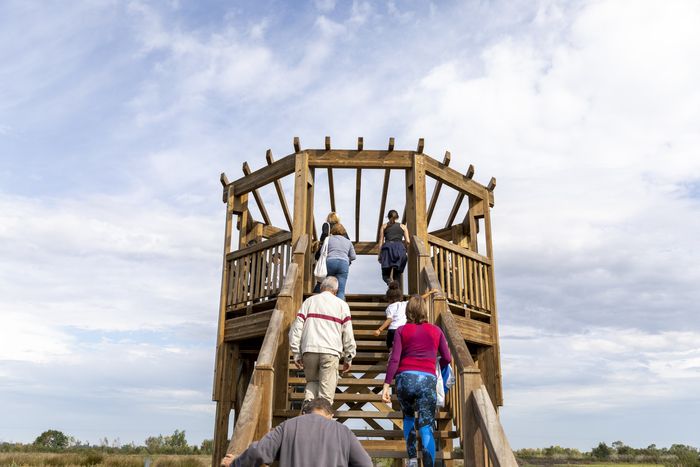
[289, 291, 357, 362]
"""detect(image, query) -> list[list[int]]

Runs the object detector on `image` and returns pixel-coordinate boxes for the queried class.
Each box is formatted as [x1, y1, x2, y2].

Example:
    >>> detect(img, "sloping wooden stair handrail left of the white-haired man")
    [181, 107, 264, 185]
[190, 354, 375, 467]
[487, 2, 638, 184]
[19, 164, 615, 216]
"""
[221, 236, 308, 458]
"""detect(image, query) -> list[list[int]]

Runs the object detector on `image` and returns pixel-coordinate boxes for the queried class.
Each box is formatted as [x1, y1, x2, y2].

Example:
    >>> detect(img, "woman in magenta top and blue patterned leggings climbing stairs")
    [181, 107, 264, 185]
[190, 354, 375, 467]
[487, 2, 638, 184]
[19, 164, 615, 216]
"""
[382, 295, 452, 467]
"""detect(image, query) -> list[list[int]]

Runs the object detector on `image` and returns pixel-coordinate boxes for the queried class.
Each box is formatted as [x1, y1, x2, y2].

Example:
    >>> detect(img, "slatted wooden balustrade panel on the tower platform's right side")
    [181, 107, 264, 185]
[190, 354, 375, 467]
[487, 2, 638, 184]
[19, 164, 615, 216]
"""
[428, 235, 494, 315]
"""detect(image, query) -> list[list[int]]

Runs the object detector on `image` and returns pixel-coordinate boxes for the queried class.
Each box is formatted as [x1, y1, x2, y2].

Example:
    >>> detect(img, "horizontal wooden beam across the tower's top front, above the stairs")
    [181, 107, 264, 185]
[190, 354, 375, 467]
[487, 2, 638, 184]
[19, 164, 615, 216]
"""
[304, 149, 415, 169]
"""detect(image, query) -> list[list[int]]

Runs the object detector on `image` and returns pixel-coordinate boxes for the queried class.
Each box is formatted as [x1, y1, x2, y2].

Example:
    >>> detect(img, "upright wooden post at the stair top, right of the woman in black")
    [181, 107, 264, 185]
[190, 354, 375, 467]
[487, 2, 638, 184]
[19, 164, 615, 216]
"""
[406, 154, 428, 294]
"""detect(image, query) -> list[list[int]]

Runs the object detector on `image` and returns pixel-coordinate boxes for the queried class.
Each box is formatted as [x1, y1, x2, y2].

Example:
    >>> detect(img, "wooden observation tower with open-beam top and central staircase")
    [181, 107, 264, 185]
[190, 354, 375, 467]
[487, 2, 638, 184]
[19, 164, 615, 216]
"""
[213, 137, 517, 467]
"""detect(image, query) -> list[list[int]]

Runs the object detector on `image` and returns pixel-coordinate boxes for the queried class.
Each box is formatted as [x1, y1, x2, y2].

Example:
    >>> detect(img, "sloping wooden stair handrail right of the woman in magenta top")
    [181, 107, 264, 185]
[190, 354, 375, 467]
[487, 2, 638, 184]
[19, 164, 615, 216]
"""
[413, 237, 518, 467]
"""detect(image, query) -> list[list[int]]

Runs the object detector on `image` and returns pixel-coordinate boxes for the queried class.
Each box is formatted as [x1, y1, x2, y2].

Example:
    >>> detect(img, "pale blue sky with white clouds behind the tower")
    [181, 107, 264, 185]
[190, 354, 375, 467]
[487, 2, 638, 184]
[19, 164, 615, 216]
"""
[0, 0, 700, 450]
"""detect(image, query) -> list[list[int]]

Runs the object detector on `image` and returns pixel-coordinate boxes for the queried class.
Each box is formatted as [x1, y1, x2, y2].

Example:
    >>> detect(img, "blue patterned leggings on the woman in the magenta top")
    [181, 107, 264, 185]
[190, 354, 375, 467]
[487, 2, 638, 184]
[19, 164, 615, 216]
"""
[396, 372, 437, 467]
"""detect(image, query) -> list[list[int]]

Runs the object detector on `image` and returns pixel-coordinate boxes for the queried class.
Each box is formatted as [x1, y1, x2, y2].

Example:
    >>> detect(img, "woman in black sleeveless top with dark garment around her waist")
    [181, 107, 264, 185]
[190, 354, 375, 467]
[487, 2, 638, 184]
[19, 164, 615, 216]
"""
[377, 209, 411, 285]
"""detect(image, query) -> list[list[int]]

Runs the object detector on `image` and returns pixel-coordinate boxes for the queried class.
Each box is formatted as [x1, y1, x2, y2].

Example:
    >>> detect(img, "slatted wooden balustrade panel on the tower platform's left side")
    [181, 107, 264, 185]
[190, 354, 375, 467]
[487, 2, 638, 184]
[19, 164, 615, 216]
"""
[226, 232, 292, 311]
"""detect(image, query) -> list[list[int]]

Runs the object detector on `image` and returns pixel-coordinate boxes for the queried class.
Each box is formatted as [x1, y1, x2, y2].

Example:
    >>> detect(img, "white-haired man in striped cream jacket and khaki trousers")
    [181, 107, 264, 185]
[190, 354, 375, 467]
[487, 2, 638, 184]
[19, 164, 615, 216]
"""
[289, 276, 357, 404]
